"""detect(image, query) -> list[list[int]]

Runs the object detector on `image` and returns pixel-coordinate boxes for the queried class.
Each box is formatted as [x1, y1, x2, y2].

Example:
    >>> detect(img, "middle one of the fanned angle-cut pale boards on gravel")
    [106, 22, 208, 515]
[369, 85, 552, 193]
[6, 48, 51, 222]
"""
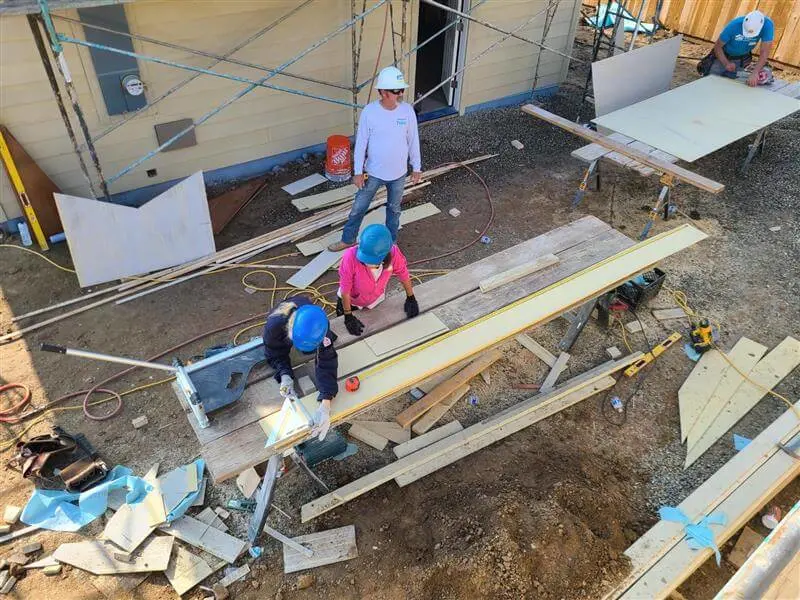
[686, 337, 767, 454]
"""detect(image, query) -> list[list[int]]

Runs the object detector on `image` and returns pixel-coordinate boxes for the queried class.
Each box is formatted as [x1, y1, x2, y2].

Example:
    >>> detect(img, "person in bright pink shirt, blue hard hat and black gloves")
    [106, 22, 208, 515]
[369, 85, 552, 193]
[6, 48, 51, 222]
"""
[336, 224, 419, 335]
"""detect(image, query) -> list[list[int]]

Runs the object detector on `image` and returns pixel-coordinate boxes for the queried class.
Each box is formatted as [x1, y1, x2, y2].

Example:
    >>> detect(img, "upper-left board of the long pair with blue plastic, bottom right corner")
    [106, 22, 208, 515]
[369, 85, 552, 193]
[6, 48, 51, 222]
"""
[611, 402, 800, 598]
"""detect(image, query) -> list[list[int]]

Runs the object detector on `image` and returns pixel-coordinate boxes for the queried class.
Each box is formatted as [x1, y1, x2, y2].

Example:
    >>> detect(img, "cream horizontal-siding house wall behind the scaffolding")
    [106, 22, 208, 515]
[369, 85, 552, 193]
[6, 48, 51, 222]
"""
[0, 0, 577, 219]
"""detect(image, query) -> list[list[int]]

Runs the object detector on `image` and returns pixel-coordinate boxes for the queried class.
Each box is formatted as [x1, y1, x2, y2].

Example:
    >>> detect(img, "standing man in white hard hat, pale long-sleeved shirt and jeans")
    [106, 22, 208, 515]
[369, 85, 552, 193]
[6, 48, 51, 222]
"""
[328, 67, 422, 252]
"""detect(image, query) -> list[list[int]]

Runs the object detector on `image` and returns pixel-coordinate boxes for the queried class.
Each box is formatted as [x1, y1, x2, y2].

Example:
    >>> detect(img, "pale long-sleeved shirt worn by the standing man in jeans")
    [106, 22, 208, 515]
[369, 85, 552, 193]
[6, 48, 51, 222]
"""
[354, 100, 422, 181]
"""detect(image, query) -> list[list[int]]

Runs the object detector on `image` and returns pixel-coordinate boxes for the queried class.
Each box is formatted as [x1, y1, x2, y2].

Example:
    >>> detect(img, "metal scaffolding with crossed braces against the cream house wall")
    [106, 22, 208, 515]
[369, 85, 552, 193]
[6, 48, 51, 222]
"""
[29, 0, 582, 199]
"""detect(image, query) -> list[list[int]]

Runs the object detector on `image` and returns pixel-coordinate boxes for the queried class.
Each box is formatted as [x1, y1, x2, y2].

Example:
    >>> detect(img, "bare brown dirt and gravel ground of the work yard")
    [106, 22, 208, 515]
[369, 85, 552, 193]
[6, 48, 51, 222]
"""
[0, 23, 800, 600]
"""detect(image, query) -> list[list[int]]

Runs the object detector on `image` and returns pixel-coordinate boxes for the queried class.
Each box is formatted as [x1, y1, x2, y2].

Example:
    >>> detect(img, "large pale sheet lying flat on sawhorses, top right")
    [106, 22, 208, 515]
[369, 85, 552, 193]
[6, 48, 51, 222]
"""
[594, 76, 800, 162]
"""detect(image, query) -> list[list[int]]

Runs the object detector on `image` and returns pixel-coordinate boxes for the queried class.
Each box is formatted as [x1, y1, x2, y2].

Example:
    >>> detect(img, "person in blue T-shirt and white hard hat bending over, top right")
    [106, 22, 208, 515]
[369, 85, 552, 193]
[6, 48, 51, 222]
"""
[698, 10, 775, 86]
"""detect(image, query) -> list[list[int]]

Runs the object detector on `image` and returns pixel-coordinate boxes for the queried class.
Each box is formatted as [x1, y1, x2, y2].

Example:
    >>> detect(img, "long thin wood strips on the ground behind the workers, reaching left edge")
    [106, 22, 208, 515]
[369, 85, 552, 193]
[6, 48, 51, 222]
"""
[0, 155, 494, 343]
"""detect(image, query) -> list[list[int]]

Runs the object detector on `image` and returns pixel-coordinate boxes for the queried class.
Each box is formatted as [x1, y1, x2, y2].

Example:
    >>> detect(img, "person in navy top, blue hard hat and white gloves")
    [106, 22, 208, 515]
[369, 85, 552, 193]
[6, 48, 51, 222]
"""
[264, 296, 339, 440]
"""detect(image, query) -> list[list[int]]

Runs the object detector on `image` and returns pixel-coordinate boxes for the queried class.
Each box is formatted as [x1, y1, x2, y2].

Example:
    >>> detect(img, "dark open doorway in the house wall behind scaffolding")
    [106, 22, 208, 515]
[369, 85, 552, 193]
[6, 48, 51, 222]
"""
[414, 0, 465, 121]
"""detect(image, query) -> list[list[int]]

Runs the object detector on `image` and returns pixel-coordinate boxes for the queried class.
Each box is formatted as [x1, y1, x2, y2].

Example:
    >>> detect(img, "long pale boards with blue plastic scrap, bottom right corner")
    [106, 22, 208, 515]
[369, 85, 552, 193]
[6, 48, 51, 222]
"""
[609, 402, 800, 600]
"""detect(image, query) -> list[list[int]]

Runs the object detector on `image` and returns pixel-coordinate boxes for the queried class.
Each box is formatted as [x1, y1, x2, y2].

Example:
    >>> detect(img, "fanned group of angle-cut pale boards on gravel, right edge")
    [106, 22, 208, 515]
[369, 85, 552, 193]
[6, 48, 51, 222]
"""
[678, 337, 800, 468]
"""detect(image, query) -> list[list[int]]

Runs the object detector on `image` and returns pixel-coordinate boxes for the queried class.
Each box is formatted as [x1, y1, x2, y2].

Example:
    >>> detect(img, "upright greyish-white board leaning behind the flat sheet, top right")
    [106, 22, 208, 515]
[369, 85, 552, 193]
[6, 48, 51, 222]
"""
[592, 35, 683, 117]
